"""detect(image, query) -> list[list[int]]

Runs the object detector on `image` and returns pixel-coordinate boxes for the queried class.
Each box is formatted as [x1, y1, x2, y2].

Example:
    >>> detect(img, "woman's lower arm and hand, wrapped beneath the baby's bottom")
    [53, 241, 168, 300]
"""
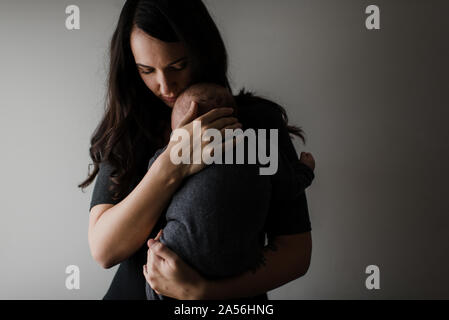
[143, 232, 312, 300]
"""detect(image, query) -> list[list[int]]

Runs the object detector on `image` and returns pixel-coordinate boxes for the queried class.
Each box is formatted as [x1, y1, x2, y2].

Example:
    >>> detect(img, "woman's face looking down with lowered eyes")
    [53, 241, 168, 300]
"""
[131, 28, 192, 108]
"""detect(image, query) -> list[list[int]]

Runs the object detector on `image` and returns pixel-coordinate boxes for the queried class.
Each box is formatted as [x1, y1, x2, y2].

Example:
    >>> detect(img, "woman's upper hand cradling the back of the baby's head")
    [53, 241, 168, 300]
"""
[163, 101, 242, 178]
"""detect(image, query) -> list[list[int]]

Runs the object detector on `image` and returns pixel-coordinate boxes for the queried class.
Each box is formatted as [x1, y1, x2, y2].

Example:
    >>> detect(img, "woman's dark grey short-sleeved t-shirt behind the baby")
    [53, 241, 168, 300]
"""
[90, 100, 314, 300]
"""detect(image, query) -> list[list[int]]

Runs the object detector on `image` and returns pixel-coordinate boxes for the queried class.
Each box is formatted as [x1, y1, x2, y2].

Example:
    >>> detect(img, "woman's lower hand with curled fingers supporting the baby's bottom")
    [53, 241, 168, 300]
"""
[143, 230, 206, 300]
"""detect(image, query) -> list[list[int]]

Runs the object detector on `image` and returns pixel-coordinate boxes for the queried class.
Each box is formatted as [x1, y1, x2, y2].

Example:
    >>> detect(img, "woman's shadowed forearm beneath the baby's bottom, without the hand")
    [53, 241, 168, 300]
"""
[199, 233, 311, 300]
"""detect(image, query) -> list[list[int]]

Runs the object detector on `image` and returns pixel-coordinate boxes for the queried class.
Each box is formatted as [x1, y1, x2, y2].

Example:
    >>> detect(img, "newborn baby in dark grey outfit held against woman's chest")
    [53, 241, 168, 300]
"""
[146, 83, 311, 300]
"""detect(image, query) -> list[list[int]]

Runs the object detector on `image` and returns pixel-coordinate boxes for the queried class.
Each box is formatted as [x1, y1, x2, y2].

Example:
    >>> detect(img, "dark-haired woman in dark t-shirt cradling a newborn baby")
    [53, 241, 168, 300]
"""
[79, 0, 311, 299]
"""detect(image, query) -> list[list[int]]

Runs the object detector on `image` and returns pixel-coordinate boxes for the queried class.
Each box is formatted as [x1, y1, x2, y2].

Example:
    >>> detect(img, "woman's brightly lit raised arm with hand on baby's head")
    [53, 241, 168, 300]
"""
[88, 103, 237, 268]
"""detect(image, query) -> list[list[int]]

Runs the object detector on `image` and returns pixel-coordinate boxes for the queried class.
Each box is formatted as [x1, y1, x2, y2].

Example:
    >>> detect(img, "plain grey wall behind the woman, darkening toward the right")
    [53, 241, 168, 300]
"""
[0, 0, 449, 299]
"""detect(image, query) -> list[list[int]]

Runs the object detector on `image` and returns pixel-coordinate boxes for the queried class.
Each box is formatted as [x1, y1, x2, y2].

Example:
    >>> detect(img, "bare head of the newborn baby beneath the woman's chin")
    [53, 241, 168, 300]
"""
[171, 83, 236, 130]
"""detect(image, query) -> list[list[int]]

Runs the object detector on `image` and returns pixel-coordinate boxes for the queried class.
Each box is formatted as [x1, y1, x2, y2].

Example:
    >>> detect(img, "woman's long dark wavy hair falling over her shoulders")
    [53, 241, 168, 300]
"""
[78, 0, 305, 199]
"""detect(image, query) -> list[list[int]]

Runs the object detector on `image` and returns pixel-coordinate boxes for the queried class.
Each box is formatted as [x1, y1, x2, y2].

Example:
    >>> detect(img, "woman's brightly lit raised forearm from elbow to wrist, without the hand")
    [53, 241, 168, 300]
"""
[89, 153, 182, 268]
